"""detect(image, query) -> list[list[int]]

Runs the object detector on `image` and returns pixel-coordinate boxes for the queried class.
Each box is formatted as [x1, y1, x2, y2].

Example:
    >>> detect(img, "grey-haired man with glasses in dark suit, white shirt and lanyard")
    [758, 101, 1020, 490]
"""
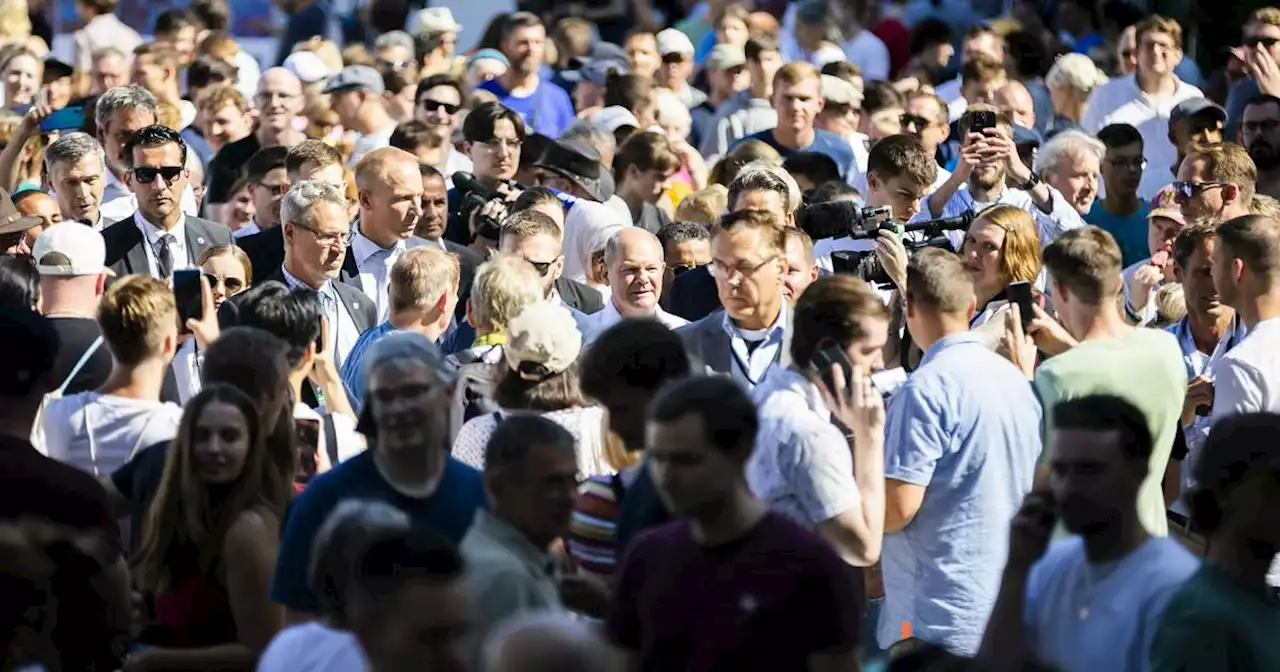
[264, 182, 378, 370]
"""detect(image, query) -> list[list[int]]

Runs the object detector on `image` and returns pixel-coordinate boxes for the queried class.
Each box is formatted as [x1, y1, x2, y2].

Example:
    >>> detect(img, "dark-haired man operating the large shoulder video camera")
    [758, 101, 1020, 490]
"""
[814, 134, 938, 288]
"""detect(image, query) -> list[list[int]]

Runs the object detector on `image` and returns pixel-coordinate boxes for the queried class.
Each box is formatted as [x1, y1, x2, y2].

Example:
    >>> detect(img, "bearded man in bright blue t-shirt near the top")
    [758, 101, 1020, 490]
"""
[480, 12, 573, 138]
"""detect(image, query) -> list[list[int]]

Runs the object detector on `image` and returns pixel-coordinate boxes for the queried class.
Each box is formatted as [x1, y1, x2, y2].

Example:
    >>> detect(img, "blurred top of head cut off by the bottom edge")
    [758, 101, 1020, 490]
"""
[484, 612, 622, 672]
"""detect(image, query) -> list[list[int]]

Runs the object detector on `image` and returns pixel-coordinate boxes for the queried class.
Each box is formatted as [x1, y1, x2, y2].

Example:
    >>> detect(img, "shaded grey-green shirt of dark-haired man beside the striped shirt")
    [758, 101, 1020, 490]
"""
[458, 511, 563, 643]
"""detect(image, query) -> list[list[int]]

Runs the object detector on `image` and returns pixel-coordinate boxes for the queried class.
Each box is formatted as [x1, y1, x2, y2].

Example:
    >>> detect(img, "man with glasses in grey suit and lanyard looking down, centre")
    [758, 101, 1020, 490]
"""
[676, 210, 791, 388]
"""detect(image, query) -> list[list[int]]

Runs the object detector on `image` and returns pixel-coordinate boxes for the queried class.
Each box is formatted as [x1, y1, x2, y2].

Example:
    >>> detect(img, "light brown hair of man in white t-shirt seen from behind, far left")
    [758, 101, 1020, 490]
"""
[97, 275, 178, 366]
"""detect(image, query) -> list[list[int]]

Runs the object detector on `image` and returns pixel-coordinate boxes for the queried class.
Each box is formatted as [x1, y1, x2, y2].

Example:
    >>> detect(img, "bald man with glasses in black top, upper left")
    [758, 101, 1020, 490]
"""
[205, 68, 306, 205]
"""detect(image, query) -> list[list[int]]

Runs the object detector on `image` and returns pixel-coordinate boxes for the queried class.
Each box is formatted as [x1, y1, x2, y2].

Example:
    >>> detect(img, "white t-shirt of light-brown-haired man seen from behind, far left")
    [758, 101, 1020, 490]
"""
[42, 392, 182, 476]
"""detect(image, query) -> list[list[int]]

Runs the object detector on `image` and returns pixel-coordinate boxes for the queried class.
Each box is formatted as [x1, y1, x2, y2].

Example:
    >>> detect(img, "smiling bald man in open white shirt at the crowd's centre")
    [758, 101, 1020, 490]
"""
[582, 227, 689, 343]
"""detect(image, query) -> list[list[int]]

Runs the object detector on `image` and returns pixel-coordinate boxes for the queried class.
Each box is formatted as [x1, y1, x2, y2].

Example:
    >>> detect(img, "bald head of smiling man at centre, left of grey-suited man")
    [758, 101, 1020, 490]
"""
[604, 227, 667, 317]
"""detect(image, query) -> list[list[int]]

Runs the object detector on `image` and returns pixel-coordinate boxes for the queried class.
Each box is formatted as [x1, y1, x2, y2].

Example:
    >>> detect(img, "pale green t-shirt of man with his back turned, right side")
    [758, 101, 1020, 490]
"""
[1036, 329, 1187, 536]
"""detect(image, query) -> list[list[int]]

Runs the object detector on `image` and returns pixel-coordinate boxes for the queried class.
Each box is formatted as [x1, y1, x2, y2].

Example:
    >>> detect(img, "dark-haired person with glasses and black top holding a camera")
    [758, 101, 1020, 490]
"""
[444, 102, 525, 244]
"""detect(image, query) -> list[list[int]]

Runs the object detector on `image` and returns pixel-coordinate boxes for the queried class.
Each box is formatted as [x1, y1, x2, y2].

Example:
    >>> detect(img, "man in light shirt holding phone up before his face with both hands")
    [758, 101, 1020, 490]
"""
[914, 105, 1084, 246]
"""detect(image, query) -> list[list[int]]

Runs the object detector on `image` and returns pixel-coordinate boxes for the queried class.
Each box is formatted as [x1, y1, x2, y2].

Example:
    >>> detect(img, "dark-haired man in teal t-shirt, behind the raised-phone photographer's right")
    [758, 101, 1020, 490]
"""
[1084, 124, 1148, 266]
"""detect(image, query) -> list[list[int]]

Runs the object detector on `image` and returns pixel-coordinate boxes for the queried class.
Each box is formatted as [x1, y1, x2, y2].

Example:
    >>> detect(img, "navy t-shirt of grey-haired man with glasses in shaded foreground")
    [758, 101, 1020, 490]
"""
[271, 449, 488, 613]
